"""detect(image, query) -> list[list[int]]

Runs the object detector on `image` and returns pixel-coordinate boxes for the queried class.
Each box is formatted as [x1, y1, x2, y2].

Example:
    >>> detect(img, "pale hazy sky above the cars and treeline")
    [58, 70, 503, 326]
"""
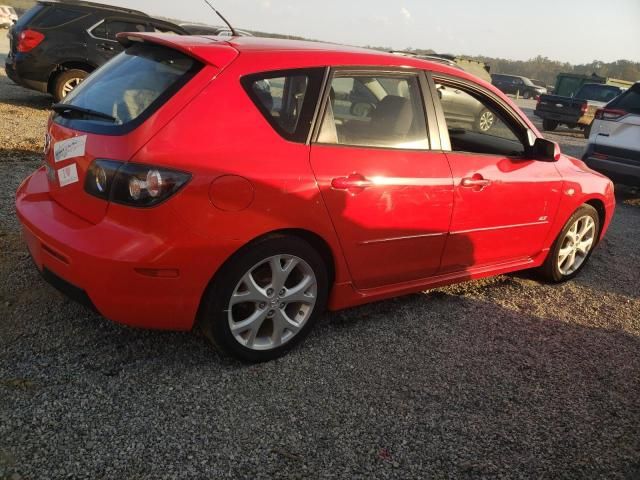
[96, 0, 640, 64]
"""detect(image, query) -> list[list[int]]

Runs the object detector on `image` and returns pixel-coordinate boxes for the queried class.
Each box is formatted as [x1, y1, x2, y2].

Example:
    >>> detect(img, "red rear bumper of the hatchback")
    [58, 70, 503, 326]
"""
[16, 169, 221, 330]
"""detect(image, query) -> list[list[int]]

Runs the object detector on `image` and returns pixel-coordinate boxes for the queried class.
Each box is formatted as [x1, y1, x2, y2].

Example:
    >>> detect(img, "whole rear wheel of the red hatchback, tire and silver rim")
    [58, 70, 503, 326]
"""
[198, 235, 329, 362]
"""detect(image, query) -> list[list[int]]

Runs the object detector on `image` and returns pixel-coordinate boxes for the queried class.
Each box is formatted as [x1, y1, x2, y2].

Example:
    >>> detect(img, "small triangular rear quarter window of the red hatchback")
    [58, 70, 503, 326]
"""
[242, 68, 324, 142]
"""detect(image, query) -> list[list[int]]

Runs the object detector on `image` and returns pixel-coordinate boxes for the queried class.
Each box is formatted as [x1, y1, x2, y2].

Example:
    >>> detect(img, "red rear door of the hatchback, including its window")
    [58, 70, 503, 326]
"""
[311, 69, 453, 289]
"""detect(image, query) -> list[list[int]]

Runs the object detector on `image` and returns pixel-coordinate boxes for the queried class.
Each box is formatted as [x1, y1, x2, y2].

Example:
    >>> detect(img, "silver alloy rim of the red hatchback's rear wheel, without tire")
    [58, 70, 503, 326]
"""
[227, 255, 318, 350]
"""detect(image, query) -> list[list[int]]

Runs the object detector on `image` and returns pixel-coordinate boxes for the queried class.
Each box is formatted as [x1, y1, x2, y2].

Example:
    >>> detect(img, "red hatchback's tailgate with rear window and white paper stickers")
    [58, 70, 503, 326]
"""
[45, 34, 238, 223]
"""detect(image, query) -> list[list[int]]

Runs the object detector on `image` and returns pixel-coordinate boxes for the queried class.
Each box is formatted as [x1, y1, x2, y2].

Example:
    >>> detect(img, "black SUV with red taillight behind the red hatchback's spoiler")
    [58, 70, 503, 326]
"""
[5, 0, 188, 102]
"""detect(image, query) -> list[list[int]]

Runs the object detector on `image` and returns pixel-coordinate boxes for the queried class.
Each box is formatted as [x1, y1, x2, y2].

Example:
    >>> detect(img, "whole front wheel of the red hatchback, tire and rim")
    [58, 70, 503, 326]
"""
[541, 204, 600, 283]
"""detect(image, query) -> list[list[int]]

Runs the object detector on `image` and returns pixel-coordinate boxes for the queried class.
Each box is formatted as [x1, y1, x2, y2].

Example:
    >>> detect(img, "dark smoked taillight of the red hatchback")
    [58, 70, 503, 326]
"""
[84, 160, 191, 207]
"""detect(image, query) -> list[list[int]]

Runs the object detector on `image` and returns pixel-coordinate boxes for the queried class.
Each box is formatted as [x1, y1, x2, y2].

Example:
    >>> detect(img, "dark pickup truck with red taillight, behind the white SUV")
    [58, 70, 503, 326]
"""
[533, 83, 624, 138]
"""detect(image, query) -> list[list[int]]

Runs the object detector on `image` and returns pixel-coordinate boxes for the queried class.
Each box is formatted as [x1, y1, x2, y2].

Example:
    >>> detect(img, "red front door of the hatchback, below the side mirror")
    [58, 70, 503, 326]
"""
[434, 75, 562, 273]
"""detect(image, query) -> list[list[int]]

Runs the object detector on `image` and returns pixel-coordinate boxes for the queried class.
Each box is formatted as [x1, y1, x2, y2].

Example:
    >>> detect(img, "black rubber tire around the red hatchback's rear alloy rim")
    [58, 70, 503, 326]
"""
[199, 236, 329, 362]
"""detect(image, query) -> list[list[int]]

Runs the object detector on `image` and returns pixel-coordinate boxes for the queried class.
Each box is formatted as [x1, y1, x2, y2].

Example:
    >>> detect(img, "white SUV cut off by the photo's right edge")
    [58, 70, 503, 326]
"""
[582, 82, 640, 186]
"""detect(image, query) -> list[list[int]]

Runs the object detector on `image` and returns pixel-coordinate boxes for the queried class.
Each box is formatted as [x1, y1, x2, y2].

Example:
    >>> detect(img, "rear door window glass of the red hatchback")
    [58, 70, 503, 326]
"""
[318, 74, 429, 149]
